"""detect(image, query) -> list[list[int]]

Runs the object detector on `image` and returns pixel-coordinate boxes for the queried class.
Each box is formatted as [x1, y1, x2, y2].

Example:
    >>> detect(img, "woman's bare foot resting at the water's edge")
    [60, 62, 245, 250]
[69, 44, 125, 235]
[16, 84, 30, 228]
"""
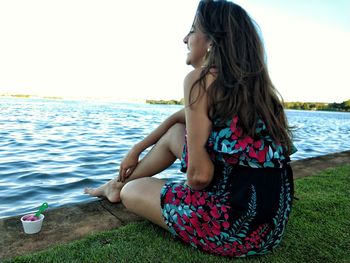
[84, 179, 124, 203]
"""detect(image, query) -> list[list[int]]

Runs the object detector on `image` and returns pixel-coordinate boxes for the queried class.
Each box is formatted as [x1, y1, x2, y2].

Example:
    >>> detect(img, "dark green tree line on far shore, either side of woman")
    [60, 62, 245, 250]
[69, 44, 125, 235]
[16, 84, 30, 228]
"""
[146, 99, 350, 112]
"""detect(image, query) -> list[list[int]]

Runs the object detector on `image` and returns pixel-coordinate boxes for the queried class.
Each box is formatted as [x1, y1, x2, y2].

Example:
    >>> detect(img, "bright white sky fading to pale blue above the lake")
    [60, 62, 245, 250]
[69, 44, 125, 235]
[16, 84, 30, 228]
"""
[0, 0, 350, 102]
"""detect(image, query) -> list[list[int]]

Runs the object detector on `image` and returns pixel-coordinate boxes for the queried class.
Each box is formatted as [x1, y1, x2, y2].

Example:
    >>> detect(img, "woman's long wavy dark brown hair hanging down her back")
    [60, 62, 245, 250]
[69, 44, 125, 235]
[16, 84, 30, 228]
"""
[190, 0, 292, 155]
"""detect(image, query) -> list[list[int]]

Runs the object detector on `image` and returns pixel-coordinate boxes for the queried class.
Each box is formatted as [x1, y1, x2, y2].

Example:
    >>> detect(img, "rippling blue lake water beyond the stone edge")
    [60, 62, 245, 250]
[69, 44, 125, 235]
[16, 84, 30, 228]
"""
[0, 98, 350, 218]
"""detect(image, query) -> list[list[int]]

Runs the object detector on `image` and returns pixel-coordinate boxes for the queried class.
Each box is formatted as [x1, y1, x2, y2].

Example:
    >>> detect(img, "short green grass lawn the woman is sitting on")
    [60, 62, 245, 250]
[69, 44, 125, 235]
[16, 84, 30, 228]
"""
[5, 165, 350, 263]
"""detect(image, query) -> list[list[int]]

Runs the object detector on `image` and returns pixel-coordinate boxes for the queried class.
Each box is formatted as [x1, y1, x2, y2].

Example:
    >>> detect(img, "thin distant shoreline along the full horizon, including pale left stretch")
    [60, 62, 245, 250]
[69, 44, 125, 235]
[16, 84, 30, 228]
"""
[0, 93, 350, 112]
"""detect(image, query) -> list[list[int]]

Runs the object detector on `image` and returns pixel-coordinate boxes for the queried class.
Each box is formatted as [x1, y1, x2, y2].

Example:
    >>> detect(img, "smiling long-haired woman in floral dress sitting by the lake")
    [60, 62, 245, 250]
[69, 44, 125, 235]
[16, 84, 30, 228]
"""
[86, 1, 293, 256]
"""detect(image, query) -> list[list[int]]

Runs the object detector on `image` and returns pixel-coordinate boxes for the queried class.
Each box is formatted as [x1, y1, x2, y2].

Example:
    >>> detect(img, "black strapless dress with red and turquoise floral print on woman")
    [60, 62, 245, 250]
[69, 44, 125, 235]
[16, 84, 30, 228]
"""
[161, 117, 293, 257]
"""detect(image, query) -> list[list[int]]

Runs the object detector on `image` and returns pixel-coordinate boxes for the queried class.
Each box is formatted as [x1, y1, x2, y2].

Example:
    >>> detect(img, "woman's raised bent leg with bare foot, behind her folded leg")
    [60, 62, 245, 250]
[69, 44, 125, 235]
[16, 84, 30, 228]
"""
[85, 123, 185, 202]
